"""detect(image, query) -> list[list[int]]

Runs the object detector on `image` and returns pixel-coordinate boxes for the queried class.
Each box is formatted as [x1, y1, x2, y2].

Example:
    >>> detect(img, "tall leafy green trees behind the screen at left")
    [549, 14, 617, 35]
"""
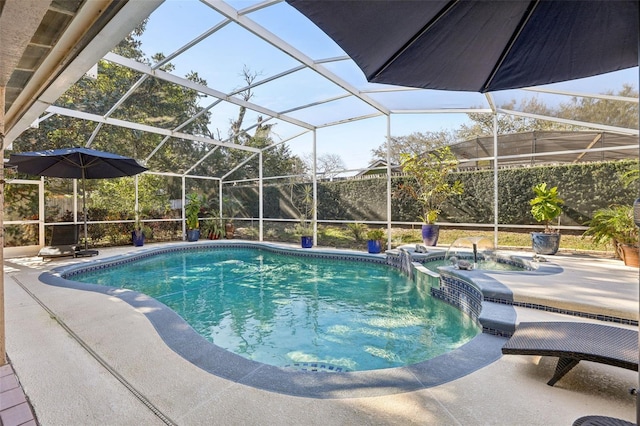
[14, 22, 303, 220]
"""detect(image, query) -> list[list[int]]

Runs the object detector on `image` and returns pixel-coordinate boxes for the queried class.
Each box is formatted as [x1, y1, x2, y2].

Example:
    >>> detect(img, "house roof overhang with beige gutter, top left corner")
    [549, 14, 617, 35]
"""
[0, 0, 164, 148]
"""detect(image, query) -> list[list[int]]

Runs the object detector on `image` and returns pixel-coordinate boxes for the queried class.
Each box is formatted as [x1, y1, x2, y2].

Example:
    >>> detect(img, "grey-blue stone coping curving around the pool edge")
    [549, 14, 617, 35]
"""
[39, 241, 515, 399]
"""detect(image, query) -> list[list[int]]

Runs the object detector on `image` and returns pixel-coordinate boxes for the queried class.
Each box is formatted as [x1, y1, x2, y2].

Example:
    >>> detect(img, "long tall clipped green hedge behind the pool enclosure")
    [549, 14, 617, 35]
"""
[225, 160, 638, 226]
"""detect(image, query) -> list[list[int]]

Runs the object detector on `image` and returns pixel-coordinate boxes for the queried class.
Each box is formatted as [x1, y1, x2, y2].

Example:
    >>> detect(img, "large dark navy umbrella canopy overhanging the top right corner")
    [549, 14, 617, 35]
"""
[287, 0, 639, 92]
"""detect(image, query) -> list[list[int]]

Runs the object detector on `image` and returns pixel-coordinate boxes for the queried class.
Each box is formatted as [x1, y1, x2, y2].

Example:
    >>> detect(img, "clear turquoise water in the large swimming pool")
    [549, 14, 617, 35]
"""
[73, 247, 480, 371]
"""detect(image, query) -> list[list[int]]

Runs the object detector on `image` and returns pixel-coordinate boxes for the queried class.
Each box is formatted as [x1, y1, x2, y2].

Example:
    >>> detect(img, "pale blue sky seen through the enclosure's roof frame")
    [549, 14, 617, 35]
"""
[134, 0, 638, 169]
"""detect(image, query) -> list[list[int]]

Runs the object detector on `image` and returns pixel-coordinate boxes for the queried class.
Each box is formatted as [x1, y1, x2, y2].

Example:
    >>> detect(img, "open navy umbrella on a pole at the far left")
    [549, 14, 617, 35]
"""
[9, 147, 147, 253]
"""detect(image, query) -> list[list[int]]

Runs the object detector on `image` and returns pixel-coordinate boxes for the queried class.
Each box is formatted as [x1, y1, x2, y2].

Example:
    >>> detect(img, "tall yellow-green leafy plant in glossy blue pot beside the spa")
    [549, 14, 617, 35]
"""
[400, 146, 464, 246]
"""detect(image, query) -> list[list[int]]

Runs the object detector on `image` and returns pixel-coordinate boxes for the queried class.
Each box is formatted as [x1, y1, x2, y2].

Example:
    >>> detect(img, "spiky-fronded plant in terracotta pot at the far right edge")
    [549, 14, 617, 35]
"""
[583, 205, 640, 267]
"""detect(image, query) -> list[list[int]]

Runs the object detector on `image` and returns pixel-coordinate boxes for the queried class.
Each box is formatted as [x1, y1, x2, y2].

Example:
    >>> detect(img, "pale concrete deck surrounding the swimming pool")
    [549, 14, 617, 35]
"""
[4, 243, 639, 426]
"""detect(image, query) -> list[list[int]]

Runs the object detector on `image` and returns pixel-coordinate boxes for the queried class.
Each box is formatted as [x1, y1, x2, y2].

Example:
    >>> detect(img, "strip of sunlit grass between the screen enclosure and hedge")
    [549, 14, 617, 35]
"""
[236, 222, 615, 257]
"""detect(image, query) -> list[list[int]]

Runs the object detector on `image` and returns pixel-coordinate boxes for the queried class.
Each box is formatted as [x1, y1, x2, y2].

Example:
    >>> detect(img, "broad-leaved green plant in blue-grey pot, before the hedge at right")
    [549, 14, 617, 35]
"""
[529, 182, 564, 254]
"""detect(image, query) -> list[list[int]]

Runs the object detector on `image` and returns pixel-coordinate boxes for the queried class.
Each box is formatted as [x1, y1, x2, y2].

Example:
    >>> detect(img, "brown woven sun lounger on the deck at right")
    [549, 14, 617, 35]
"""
[502, 322, 638, 386]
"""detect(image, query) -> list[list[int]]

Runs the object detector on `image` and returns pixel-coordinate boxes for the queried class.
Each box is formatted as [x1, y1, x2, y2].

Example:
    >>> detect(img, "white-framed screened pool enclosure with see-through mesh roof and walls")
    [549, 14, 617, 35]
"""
[4, 0, 638, 255]
